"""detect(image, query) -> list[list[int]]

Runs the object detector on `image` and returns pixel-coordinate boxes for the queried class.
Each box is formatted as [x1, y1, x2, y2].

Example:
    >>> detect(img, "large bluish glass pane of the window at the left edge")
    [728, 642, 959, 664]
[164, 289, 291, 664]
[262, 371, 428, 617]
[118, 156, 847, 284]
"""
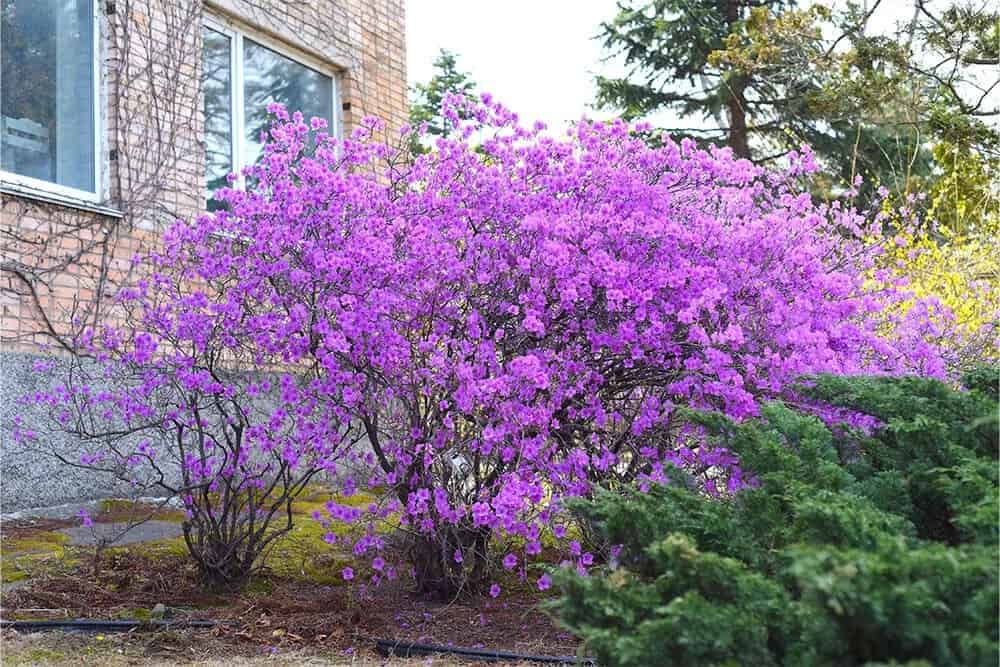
[0, 0, 96, 192]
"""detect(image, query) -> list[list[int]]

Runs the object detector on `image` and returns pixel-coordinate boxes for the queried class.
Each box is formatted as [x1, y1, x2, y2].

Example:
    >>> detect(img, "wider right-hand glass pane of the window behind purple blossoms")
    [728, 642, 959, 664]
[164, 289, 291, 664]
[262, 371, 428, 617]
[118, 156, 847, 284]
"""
[243, 39, 333, 164]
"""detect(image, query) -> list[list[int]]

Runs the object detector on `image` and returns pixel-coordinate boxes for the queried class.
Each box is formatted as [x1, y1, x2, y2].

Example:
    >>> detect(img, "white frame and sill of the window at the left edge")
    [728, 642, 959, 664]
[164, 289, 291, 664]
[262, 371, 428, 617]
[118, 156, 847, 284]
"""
[0, 0, 104, 204]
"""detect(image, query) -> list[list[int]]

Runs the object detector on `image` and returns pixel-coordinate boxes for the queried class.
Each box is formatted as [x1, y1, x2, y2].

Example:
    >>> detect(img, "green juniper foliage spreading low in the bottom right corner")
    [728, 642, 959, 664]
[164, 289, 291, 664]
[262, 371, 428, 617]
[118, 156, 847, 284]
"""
[553, 371, 998, 667]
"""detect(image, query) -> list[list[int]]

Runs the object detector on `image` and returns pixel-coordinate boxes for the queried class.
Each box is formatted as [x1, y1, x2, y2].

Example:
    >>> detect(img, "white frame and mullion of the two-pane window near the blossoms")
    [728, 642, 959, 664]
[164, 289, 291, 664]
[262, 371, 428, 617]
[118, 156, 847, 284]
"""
[202, 12, 341, 190]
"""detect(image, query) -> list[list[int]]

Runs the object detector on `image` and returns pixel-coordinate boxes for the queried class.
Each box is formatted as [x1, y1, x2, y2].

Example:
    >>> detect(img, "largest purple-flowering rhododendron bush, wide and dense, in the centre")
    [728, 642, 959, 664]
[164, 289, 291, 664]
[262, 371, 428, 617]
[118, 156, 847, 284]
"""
[19, 97, 945, 594]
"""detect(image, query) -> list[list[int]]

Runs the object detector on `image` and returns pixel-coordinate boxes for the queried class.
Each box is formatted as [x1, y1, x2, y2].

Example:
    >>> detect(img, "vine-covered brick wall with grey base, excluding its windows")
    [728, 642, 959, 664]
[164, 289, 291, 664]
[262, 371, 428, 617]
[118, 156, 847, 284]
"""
[0, 0, 407, 510]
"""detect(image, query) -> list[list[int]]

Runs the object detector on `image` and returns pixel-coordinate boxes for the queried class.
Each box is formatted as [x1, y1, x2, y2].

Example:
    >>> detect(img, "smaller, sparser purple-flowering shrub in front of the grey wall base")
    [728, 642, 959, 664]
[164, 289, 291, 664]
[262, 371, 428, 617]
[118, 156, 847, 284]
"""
[14, 244, 361, 589]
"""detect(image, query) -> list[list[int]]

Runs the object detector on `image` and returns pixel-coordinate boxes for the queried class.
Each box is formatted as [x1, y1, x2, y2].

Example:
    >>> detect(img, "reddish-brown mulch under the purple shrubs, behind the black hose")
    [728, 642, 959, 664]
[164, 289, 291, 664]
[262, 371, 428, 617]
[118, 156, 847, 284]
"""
[0, 551, 577, 655]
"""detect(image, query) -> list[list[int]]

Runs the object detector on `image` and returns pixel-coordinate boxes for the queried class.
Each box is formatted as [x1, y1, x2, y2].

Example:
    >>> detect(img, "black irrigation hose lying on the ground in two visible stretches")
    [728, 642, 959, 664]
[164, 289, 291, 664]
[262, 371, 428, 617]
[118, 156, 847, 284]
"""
[0, 618, 597, 667]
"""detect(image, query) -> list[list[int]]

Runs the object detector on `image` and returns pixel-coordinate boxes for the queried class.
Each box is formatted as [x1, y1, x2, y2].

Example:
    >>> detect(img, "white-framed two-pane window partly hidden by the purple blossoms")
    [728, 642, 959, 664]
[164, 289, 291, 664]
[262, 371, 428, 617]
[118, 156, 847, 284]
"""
[202, 21, 336, 210]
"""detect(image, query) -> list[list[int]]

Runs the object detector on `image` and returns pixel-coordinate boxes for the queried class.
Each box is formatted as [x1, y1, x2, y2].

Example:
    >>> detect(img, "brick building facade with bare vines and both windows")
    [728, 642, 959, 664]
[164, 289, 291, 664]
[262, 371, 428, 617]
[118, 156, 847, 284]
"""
[0, 0, 407, 511]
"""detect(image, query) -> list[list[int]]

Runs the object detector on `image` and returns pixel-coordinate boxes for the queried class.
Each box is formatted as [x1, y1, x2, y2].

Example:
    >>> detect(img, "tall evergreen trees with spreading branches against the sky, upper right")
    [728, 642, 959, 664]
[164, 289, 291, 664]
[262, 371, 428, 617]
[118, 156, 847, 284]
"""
[597, 0, 1000, 209]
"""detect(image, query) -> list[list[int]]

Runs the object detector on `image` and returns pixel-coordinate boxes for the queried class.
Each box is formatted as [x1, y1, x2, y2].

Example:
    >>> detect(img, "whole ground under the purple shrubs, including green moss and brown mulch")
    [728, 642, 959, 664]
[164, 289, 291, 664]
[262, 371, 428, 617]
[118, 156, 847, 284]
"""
[3, 487, 575, 667]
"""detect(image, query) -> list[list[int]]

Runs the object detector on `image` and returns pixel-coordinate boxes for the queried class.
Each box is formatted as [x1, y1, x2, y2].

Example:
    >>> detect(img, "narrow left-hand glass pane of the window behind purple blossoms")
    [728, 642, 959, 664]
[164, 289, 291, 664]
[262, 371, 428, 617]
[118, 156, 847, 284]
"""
[202, 28, 233, 211]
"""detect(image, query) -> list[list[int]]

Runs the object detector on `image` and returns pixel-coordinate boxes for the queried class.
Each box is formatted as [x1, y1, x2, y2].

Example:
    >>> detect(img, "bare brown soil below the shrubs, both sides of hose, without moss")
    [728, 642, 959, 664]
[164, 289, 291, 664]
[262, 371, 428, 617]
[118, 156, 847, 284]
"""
[0, 525, 578, 665]
